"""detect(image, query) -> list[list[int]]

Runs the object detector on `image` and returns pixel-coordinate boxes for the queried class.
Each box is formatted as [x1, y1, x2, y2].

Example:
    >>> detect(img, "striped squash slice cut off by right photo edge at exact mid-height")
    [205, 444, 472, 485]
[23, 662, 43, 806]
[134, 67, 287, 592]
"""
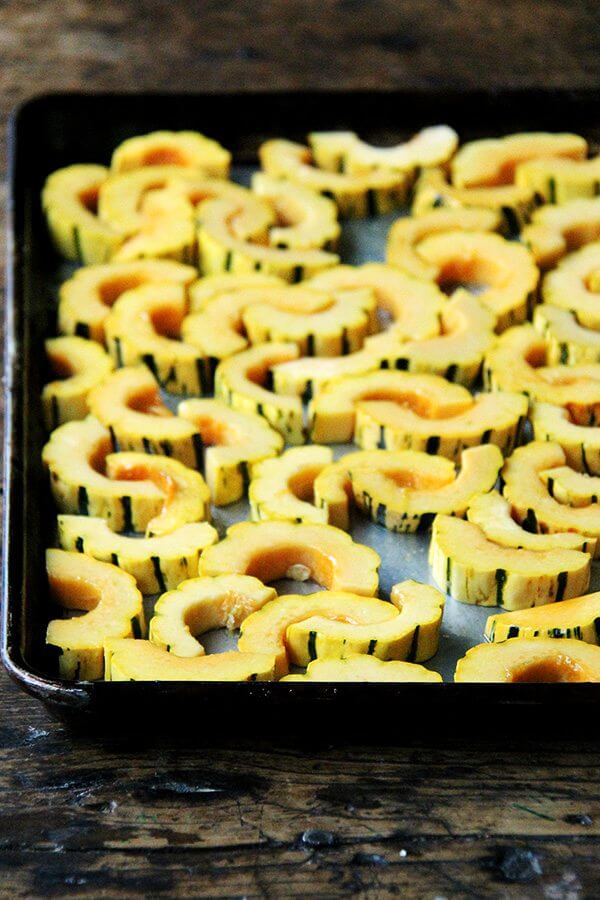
[531, 403, 600, 475]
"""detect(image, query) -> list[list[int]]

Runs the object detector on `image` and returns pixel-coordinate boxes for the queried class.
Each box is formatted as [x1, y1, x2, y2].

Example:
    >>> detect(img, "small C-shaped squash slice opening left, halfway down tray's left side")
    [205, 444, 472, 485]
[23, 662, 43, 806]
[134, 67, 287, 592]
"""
[42, 335, 114, 431]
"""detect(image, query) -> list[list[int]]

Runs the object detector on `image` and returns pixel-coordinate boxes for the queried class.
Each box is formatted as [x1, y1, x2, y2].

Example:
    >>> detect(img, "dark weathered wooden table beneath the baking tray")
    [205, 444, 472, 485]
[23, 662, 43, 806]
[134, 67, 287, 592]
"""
[0, 0, 600, 900]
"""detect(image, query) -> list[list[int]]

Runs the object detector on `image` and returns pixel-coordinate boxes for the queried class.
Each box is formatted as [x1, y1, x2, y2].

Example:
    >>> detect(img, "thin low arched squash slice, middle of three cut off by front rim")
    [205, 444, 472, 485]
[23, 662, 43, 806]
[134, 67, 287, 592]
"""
[280, 653, 442, 684]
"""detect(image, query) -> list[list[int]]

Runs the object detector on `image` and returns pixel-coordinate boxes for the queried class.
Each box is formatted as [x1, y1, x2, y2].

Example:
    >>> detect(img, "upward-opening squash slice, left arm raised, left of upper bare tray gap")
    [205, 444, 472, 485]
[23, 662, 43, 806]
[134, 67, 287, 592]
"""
[198, 198, 339, 283]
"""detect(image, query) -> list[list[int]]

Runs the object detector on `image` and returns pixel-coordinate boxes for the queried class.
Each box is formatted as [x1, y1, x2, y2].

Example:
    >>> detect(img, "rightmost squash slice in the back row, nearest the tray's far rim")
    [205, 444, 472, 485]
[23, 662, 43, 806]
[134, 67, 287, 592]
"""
[451, 131, 588, 187]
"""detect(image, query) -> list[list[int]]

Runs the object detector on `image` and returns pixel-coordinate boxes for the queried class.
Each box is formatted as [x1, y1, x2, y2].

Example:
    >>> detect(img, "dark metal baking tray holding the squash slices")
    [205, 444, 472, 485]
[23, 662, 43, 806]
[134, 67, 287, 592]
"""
[1, 91, 600, 724]
